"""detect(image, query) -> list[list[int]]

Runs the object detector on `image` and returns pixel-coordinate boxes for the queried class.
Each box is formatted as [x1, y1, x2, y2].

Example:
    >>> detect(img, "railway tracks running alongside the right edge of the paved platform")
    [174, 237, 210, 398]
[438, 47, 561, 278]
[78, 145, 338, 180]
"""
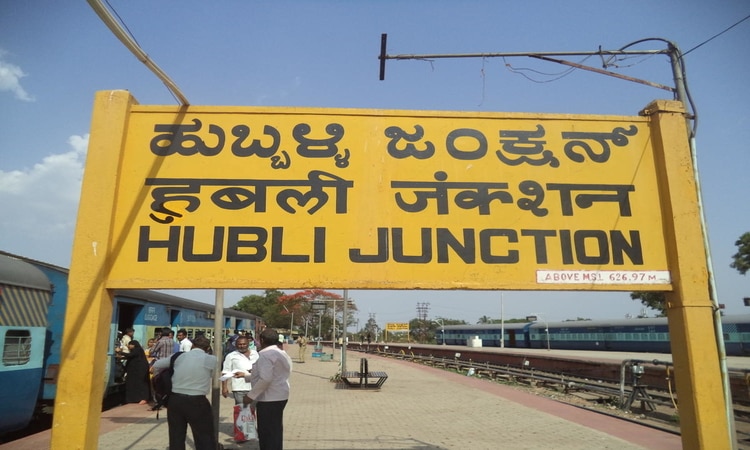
[348, 345, 750, 450]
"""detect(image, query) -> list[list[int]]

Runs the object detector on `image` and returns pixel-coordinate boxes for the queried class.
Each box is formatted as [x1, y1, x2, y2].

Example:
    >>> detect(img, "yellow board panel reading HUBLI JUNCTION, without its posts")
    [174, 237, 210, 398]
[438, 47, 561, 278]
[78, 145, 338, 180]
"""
[103, 105, 671, 291]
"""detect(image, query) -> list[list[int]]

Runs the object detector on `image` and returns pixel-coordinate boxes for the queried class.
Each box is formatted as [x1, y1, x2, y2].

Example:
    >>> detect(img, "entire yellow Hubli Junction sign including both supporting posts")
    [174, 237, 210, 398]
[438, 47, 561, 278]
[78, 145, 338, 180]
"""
[57, 91, 732, 449]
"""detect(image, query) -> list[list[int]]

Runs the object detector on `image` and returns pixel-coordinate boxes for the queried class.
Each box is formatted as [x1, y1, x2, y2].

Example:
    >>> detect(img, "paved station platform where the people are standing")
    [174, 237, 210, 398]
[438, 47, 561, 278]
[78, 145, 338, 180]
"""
[5, 346, 682, 450]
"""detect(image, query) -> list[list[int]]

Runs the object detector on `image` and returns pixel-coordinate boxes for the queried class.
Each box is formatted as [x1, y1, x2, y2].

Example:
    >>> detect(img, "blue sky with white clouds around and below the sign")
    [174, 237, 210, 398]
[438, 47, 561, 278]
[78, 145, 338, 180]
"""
[0, 0, 750, 326]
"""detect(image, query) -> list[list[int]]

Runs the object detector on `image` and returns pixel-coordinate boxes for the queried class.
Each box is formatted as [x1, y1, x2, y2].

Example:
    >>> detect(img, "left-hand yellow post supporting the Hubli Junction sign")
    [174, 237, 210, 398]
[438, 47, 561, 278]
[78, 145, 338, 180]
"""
[51, 91, 136, 450]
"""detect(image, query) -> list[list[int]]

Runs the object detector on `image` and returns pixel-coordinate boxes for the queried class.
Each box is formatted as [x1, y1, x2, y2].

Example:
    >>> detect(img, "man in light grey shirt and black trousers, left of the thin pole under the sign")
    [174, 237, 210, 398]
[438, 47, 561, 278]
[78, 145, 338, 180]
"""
[154, 336, 217, 450]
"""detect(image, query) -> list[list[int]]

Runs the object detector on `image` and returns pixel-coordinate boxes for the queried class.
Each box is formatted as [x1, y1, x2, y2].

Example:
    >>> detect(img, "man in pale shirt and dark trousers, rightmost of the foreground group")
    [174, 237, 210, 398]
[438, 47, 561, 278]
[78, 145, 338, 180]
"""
[235, 328, 292, 450]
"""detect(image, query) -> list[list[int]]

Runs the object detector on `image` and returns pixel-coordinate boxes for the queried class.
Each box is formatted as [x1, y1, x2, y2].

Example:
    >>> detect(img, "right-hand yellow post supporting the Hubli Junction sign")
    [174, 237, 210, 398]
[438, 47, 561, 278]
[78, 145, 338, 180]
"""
[644, 101, 733, 450]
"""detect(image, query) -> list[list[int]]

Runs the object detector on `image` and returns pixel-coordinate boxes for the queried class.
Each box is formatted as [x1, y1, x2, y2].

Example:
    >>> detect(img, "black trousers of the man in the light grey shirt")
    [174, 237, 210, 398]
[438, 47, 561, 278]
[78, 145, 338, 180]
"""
[167, 393, 216, 450]
